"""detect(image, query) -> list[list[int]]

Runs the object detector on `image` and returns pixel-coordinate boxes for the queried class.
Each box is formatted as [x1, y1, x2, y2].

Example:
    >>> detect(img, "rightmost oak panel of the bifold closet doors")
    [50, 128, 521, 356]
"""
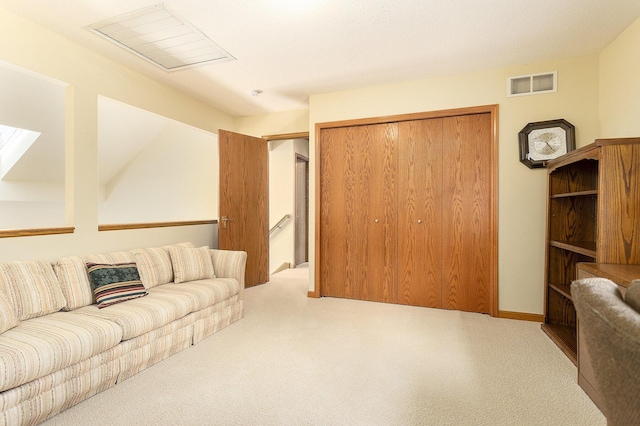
[442, 113, 496, 313]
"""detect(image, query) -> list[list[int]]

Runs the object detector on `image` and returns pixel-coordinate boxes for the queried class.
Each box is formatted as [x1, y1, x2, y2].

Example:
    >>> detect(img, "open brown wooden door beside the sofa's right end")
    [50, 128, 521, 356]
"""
[218, 130, 269, 287]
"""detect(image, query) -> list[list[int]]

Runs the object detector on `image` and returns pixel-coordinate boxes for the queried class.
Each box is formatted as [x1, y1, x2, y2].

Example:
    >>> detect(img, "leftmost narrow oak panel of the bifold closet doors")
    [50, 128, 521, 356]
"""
[319, 127, 360, 298]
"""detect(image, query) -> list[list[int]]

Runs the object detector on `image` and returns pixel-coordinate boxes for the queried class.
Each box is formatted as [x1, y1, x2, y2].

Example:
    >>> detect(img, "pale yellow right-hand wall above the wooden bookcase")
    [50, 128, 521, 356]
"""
[600, 15, 640, 138]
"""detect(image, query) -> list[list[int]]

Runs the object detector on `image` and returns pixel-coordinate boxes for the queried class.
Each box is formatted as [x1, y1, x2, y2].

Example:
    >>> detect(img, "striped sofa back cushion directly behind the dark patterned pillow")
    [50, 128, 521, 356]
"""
[53, 252, 134, 311]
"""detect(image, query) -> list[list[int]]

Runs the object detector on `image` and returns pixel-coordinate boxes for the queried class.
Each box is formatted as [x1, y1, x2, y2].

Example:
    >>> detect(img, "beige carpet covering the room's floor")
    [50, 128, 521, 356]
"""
[45, 269, 606, 426]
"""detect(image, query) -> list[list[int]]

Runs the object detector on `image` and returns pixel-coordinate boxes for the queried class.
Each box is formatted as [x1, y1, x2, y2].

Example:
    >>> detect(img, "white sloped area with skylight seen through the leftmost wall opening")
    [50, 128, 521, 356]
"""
[0, 61, 67, 228]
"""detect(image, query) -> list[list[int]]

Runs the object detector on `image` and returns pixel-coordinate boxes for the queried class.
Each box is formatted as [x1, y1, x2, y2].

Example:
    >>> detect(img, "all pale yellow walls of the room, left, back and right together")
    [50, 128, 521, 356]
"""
[0, 2, 640, 314]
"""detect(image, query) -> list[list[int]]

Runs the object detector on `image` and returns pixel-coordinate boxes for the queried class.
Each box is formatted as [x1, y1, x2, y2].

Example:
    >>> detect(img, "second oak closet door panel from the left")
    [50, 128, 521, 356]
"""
[354, 123, 398, 303]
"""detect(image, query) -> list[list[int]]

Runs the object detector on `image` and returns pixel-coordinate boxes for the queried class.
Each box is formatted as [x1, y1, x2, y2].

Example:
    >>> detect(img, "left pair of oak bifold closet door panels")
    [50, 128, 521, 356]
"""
[320, 123, 397, 303]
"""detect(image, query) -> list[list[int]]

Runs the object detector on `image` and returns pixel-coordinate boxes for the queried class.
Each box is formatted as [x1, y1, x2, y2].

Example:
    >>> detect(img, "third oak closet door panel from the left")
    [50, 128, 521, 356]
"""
[398, 118, 443, 308]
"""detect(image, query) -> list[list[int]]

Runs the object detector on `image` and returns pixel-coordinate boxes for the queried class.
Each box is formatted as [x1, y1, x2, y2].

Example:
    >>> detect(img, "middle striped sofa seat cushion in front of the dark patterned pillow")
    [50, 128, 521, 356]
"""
[72, 293, 193, 340]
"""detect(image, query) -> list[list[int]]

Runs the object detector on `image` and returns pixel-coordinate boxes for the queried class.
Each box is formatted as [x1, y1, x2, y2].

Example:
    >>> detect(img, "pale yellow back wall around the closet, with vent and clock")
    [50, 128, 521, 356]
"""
[309, 55, 599, 314]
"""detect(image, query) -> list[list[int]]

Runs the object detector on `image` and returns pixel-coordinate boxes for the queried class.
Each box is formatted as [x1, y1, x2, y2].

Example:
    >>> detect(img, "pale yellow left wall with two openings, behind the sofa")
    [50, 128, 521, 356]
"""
[0, 9, 235, 260]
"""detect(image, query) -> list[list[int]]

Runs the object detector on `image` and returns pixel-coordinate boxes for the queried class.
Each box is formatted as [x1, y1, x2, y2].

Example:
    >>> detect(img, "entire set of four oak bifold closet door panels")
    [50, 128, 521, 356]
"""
[317, 108, 497, 315]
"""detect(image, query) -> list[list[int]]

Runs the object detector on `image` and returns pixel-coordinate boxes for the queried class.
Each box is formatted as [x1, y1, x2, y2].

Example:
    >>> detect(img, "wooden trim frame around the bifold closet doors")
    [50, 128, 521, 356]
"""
[309, 105, 498, 317]
